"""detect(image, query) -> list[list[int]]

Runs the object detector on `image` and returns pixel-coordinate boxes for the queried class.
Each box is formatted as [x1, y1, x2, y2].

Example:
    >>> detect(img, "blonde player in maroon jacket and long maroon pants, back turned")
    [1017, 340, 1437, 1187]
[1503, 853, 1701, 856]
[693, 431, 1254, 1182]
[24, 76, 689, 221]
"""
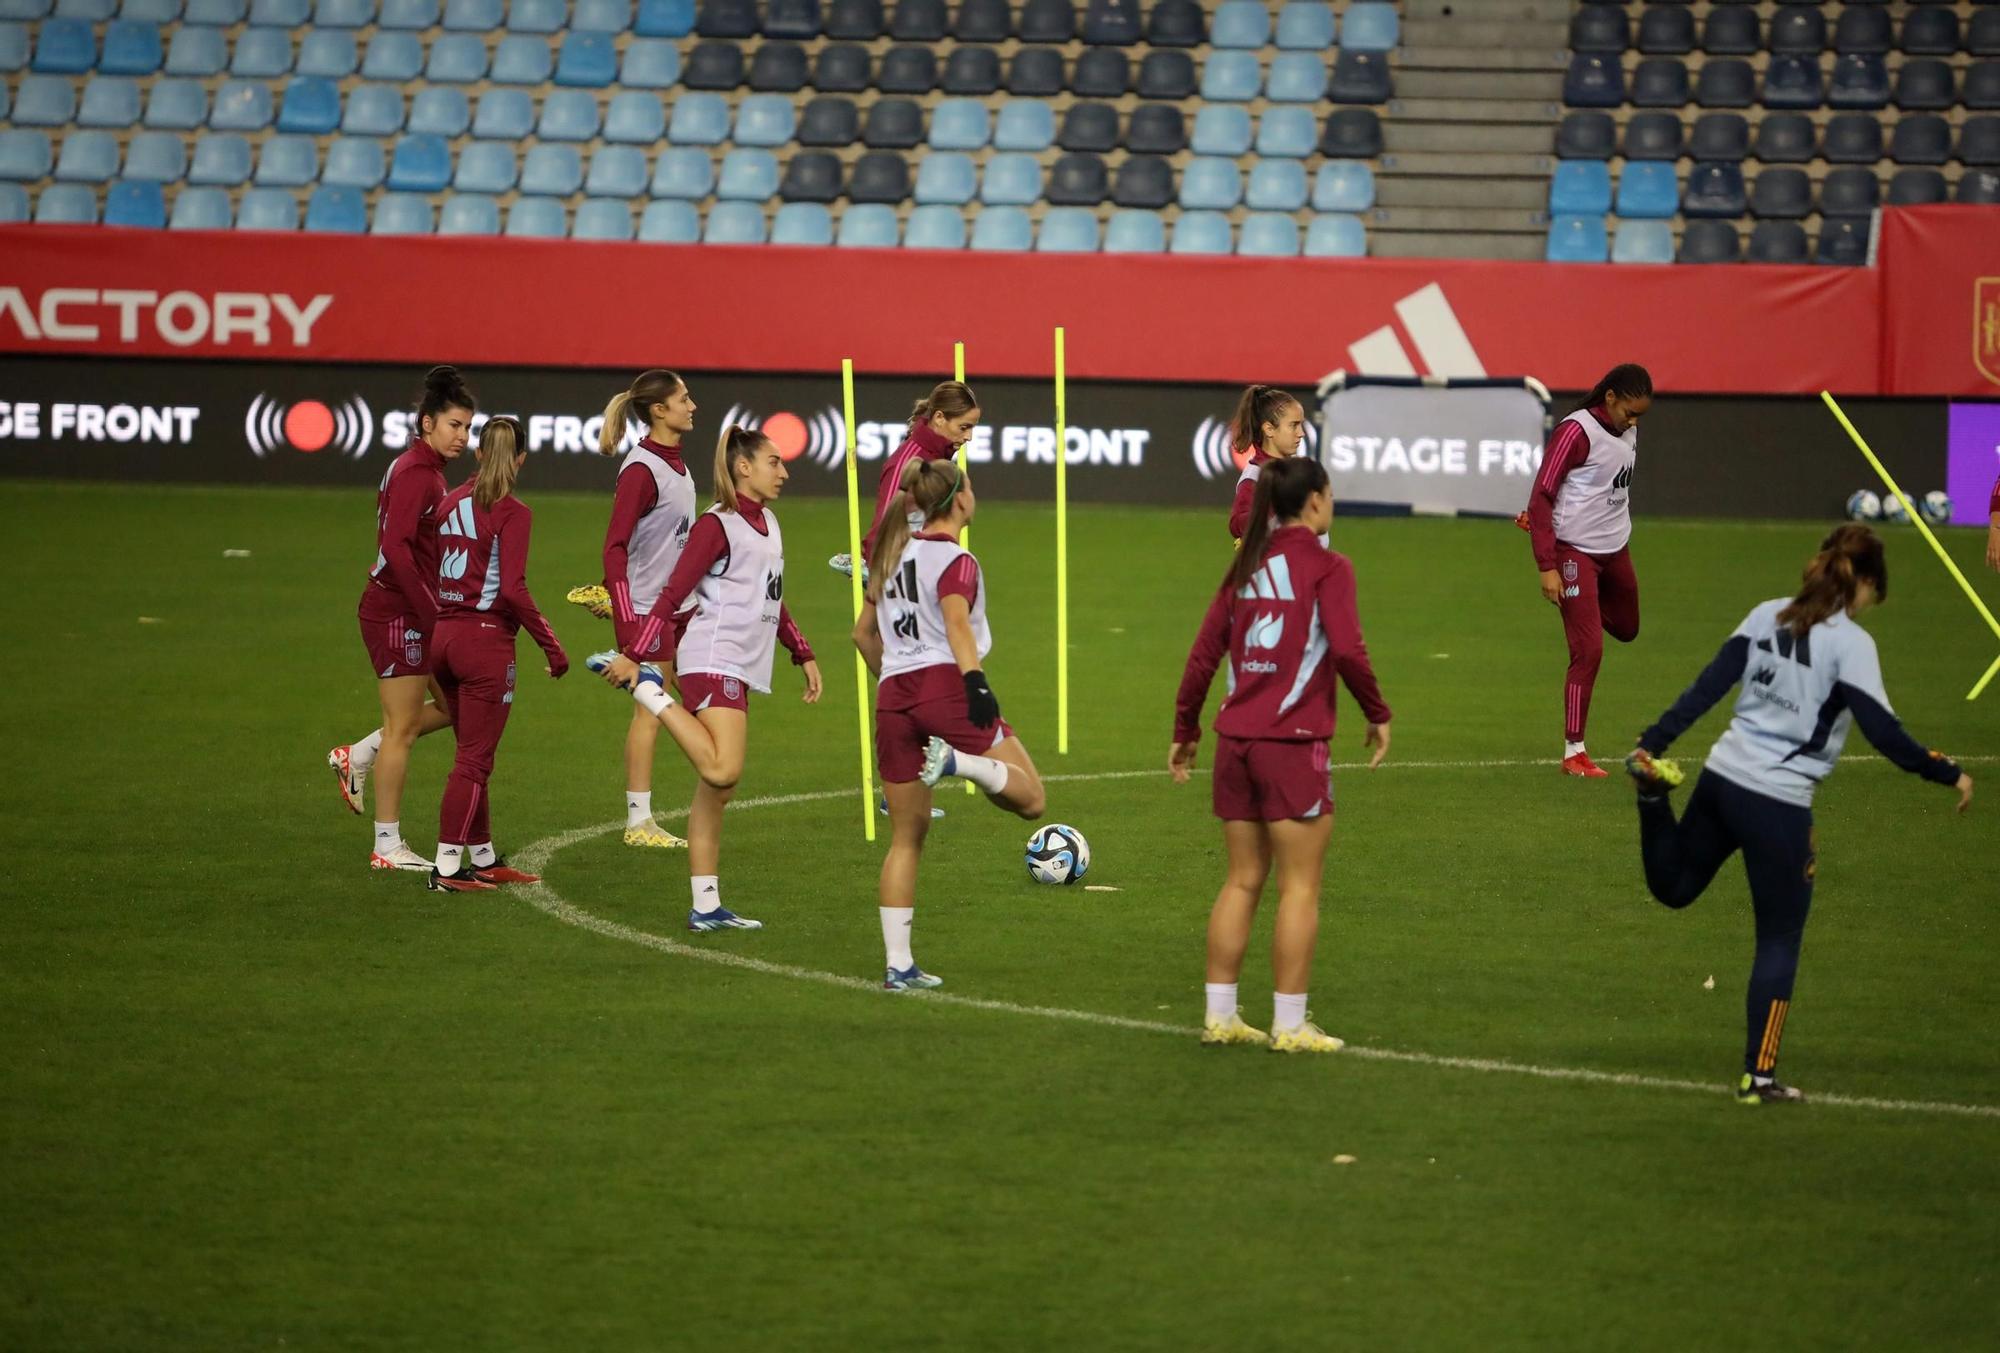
[430, 418, 570, 893]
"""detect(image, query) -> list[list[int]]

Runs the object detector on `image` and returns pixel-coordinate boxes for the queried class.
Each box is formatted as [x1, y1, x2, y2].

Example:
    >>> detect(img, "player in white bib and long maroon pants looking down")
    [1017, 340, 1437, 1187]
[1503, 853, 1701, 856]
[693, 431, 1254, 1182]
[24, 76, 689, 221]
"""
[1514, 362, 1652, 779]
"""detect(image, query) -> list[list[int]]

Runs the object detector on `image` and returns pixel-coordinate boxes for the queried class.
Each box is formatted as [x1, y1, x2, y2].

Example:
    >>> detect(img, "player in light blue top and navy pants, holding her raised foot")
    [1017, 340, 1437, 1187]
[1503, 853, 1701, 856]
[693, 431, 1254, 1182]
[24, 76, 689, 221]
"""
[1626, 524, 1972, 1105]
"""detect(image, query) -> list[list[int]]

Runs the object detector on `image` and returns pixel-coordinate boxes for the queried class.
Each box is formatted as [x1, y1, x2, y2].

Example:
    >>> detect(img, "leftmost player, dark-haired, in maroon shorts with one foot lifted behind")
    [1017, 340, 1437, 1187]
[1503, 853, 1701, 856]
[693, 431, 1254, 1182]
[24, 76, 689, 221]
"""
[326, 366, 478, 871]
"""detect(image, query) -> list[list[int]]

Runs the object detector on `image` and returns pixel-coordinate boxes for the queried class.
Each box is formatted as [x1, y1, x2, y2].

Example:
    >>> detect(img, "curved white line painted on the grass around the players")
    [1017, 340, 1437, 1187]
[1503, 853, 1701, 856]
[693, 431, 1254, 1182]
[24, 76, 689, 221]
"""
[512, 757, 2000, 1119]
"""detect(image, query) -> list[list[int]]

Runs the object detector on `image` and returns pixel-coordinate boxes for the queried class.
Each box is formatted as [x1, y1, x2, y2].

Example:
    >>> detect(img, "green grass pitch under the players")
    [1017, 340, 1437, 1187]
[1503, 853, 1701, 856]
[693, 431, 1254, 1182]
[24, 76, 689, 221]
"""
[0, 480, 2000, 1349]
